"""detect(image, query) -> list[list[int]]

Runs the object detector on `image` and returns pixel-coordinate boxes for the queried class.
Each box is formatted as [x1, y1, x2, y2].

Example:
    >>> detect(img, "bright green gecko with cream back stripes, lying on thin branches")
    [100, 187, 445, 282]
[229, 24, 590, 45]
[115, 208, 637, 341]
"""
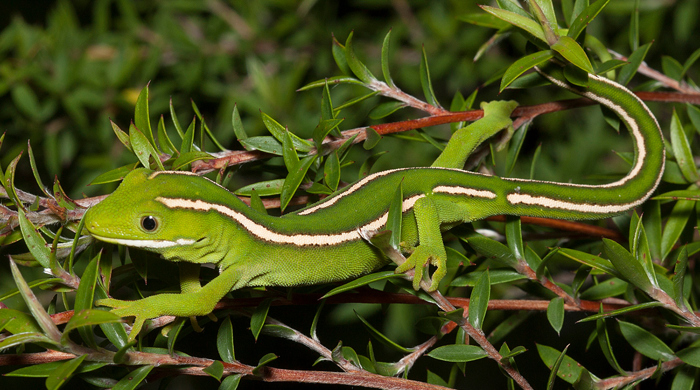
[85, 70, 665, 339]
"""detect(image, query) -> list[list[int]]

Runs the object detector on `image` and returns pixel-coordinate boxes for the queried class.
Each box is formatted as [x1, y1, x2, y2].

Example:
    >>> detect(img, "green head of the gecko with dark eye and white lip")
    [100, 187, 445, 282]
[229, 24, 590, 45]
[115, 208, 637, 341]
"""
[84, 169, 215, 263]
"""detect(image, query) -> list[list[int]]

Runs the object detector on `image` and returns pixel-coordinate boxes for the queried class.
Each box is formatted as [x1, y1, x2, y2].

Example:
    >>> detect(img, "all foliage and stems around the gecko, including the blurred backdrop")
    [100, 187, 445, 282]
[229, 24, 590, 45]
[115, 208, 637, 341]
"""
[0, 0, 700, 389]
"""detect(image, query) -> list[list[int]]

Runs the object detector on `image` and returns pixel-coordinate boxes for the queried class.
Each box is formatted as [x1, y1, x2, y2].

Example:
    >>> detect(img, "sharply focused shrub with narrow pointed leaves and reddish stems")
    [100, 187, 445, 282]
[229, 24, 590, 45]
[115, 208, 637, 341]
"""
[0, 0, 700, 389]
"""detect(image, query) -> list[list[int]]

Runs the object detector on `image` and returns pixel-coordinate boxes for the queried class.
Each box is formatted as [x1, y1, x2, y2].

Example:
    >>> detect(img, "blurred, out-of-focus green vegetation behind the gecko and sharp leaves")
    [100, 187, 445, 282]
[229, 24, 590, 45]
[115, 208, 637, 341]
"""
[0, 0, 700, 386]
